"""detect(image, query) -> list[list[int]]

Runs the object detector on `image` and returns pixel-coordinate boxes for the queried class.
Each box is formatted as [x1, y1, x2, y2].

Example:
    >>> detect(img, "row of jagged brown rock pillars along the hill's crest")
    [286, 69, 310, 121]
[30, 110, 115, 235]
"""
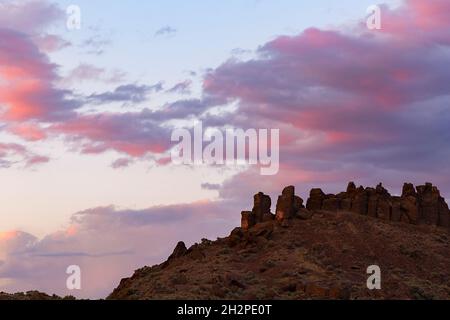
[241, 182, 450, 230]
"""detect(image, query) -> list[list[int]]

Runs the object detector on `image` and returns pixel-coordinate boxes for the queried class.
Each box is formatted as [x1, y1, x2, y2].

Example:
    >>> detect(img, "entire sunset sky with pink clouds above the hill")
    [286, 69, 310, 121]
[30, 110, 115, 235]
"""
[0, 0, 450, 298]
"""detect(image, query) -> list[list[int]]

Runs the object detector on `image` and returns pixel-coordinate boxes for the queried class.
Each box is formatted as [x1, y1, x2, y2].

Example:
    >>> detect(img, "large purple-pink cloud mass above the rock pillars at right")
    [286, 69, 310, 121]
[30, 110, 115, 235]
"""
[204, 0, 450, 190]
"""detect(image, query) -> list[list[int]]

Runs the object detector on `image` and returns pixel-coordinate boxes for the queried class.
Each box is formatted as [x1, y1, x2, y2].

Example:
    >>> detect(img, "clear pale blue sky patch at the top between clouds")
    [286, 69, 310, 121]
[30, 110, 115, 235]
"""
[52, 0, 396, 94]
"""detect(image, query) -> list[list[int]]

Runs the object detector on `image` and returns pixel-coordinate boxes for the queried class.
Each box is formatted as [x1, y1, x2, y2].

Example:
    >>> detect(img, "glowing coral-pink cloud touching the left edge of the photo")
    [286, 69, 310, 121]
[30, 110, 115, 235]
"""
[0, 29, 77, 121]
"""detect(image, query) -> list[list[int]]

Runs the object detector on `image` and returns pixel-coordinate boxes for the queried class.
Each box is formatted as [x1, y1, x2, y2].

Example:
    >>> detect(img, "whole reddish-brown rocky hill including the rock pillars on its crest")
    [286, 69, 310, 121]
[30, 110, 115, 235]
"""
[108, 182, 450, 299]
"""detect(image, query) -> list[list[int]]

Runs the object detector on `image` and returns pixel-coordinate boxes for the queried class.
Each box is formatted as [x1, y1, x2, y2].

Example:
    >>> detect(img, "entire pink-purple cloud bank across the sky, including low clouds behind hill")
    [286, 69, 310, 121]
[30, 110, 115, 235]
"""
[0, 0, 450, 296]
